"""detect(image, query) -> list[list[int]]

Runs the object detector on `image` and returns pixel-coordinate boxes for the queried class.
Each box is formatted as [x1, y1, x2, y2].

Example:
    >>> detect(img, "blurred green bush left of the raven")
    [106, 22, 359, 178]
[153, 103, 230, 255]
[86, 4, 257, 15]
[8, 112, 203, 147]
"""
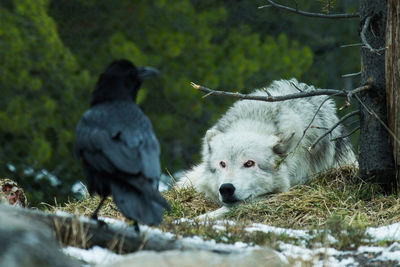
[0, 0, 92, 204]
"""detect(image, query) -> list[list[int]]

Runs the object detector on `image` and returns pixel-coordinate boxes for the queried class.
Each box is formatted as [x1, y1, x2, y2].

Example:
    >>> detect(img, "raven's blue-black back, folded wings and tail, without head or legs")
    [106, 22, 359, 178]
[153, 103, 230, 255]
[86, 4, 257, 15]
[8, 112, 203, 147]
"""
[75, 101, 169, 225]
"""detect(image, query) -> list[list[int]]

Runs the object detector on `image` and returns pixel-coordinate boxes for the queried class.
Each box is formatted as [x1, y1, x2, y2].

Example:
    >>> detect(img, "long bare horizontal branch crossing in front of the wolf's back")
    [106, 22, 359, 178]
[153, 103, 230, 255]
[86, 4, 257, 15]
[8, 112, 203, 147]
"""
[190, 82, 370, 102]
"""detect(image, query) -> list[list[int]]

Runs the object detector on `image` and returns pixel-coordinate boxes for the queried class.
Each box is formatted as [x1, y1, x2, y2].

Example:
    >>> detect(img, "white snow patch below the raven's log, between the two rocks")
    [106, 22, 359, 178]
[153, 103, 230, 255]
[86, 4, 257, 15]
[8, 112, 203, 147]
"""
[63, 246, 124, 265]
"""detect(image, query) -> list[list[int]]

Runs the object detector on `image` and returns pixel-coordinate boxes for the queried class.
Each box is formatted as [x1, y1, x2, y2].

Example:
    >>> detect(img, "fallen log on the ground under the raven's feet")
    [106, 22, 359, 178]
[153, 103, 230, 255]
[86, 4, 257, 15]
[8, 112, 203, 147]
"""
[0, 205, 245, 253]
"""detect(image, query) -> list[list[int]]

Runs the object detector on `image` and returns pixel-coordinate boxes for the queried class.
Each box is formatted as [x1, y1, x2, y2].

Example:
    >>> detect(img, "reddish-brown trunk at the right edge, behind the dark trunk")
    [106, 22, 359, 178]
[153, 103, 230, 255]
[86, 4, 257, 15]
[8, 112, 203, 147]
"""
[385, 0, 400, 188]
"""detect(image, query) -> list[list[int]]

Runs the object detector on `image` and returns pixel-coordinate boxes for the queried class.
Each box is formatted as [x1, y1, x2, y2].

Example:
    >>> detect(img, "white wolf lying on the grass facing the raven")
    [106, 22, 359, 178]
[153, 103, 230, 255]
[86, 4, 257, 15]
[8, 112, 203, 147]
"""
[178, 79, 357, 217]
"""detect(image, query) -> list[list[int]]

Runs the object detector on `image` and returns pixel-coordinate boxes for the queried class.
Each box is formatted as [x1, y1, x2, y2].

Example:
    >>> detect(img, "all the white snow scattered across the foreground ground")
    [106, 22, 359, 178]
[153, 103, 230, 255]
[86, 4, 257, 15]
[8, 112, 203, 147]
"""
[63, 218, 400, 267]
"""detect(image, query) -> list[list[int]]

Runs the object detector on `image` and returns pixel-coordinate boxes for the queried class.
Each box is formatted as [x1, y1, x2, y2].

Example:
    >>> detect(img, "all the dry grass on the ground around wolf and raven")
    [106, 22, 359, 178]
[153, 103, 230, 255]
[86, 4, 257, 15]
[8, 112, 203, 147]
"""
[50, 167, 400, 249]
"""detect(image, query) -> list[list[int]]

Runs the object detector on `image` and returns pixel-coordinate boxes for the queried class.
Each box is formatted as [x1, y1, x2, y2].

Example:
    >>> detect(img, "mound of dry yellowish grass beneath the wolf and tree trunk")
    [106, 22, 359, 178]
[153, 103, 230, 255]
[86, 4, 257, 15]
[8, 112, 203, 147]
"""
[227, 167, 400, 229]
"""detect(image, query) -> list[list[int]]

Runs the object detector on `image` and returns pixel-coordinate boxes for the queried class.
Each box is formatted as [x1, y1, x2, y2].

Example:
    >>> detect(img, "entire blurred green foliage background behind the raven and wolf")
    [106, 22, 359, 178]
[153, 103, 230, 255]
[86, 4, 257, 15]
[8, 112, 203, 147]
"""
[0, 0, 359, 205]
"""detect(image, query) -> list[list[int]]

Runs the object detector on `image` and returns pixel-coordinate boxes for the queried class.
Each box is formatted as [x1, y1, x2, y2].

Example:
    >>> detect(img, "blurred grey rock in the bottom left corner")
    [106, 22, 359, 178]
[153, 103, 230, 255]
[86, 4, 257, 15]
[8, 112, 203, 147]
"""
[0, 204, 80, 267]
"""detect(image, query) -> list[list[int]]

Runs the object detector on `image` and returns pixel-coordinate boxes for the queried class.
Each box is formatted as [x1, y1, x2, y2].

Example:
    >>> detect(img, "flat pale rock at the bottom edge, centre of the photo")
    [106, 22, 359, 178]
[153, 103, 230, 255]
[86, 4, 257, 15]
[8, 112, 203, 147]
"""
[98, 249, 288, 267]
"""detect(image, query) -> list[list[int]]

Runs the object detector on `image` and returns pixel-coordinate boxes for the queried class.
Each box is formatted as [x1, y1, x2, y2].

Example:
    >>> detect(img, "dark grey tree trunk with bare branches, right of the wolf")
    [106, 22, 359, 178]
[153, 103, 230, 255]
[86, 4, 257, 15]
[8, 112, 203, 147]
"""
[359, 0, 397, 192]
